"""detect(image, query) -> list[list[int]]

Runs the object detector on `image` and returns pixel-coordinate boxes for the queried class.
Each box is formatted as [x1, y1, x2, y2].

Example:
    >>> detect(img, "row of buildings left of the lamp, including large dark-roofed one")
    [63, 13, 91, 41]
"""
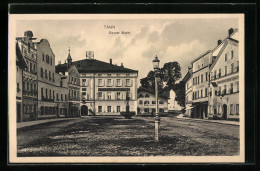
[16, 31, 138, 122]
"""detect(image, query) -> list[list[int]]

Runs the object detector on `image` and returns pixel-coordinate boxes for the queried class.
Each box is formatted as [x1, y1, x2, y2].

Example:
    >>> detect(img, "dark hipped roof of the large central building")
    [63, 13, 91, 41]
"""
[55, 59, 138, 73]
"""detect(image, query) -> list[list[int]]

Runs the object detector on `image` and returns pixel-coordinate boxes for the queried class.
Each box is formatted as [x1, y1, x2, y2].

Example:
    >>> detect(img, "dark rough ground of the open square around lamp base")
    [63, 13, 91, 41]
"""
[17, 116, 239, 156]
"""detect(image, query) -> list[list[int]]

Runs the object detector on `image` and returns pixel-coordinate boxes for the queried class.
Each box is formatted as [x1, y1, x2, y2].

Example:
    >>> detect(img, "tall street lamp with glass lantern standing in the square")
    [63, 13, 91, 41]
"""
[153, 55, 160, 141]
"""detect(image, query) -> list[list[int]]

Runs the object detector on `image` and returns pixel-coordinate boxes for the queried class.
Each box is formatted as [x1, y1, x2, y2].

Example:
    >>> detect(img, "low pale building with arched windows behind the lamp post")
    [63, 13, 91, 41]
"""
[137, 87, 168, 114]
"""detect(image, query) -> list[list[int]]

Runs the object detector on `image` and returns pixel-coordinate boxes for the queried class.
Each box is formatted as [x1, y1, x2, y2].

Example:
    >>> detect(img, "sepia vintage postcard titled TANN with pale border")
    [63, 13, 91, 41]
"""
[8, 14, 245, 163]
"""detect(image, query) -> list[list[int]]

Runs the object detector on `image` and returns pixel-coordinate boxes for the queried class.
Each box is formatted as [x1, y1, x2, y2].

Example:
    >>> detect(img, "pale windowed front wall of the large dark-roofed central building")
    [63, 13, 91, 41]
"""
[80, 73, 137, 114]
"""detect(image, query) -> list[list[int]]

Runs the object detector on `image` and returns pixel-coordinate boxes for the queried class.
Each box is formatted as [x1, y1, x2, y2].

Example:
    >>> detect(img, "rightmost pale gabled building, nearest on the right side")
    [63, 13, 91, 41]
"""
[208, 28, 239, 119]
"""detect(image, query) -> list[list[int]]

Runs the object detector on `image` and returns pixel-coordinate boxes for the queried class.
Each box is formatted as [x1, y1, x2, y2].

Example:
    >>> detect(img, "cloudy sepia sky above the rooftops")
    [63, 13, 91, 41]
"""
[16, 17, 238, 83]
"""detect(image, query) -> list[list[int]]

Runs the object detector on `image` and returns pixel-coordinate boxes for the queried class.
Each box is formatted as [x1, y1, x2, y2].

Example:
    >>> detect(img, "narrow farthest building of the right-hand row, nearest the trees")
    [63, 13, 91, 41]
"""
[182, 68, 193, 117]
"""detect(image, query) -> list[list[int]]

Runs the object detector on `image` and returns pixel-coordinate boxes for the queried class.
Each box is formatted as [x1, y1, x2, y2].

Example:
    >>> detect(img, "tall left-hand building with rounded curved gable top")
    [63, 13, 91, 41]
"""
[35, 39, 60, 118]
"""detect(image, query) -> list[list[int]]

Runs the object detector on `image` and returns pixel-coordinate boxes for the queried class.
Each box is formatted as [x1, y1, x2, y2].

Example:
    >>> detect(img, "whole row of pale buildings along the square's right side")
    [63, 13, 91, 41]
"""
[183, 28, 239, 120]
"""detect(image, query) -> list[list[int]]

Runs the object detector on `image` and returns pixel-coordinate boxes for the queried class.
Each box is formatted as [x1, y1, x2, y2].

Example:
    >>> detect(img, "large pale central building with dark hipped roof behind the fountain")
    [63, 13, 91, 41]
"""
[55, 54, 138, 116]
